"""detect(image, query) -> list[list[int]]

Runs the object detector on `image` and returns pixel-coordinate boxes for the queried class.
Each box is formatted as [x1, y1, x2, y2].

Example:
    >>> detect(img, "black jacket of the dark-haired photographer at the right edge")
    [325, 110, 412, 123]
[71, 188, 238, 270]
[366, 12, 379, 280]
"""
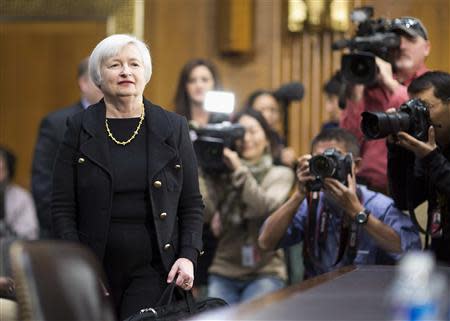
[388, 144, 450, 264]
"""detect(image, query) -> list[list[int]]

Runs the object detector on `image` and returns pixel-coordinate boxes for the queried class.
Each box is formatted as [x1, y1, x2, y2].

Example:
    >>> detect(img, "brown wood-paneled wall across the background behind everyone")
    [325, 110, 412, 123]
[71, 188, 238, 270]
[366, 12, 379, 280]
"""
[0, 0, 450, 187]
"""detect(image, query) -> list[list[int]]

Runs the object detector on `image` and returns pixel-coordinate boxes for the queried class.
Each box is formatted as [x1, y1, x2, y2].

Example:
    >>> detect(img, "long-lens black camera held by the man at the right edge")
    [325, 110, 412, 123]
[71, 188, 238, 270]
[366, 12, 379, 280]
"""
[361, 98, 431, 141]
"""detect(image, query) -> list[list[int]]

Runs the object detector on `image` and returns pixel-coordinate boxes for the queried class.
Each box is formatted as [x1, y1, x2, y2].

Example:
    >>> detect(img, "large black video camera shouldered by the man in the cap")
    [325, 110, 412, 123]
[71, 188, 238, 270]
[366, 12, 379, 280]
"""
[332, 7, 400, 85]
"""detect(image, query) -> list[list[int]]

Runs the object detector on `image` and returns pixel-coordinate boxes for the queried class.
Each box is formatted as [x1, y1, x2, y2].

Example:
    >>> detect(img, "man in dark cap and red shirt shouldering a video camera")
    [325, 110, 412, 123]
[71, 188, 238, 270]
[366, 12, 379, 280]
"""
[340, 17, 430, 193]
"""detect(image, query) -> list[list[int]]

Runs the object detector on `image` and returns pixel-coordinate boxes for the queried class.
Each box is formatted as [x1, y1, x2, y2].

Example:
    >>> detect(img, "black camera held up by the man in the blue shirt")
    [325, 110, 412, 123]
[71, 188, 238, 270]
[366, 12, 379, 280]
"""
[307, 148, 352, 192]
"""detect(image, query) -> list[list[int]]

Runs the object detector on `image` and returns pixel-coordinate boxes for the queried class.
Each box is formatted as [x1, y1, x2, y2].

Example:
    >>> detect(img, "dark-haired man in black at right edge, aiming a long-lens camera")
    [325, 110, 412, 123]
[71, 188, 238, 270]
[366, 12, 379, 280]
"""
[388, 71, 450, 265]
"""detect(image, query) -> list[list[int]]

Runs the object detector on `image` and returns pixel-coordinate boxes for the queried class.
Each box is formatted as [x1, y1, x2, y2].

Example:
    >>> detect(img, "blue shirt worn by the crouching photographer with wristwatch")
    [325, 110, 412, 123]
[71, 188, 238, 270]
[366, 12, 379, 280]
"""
[279, 185, 421, 277]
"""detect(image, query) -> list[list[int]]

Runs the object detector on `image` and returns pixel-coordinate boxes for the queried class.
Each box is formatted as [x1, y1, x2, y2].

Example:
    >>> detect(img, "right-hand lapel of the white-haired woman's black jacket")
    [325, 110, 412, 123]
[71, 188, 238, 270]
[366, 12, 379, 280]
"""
[144, 99, 177, 180]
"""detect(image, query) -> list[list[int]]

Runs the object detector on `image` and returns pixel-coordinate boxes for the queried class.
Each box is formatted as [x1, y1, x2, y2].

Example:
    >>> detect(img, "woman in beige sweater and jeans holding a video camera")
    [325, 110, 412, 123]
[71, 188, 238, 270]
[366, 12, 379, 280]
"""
[204, 110, 294, 304]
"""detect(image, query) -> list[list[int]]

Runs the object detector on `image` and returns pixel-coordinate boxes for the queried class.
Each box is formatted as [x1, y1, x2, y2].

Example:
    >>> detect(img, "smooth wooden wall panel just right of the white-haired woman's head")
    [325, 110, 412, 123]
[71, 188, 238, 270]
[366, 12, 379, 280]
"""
[145, 0, 279, 110]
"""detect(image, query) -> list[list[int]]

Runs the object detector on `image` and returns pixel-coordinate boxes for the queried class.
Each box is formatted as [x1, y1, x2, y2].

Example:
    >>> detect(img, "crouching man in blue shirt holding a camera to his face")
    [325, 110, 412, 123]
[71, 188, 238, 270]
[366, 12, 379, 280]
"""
[258, 128, 420, 278]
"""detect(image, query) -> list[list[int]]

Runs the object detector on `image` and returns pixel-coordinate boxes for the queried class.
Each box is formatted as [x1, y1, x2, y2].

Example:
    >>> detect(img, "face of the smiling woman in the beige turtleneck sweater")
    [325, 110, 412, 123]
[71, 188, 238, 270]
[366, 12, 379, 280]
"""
[238, 115, 269, 162]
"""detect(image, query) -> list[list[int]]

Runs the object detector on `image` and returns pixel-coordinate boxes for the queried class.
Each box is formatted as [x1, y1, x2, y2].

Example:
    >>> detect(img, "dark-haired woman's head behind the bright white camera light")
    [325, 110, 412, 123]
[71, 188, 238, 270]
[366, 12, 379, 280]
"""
[175, 58, 226, 127]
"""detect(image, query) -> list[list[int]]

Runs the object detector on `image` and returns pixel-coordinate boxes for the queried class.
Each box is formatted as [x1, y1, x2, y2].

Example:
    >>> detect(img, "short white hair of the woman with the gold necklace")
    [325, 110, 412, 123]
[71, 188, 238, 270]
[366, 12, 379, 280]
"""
[89, 35, 152, 87]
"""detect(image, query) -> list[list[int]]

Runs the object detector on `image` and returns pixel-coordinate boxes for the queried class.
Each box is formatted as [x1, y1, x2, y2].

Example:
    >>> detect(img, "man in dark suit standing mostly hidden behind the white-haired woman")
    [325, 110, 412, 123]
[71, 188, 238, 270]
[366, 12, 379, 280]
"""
[31, 58, 102, 238]
